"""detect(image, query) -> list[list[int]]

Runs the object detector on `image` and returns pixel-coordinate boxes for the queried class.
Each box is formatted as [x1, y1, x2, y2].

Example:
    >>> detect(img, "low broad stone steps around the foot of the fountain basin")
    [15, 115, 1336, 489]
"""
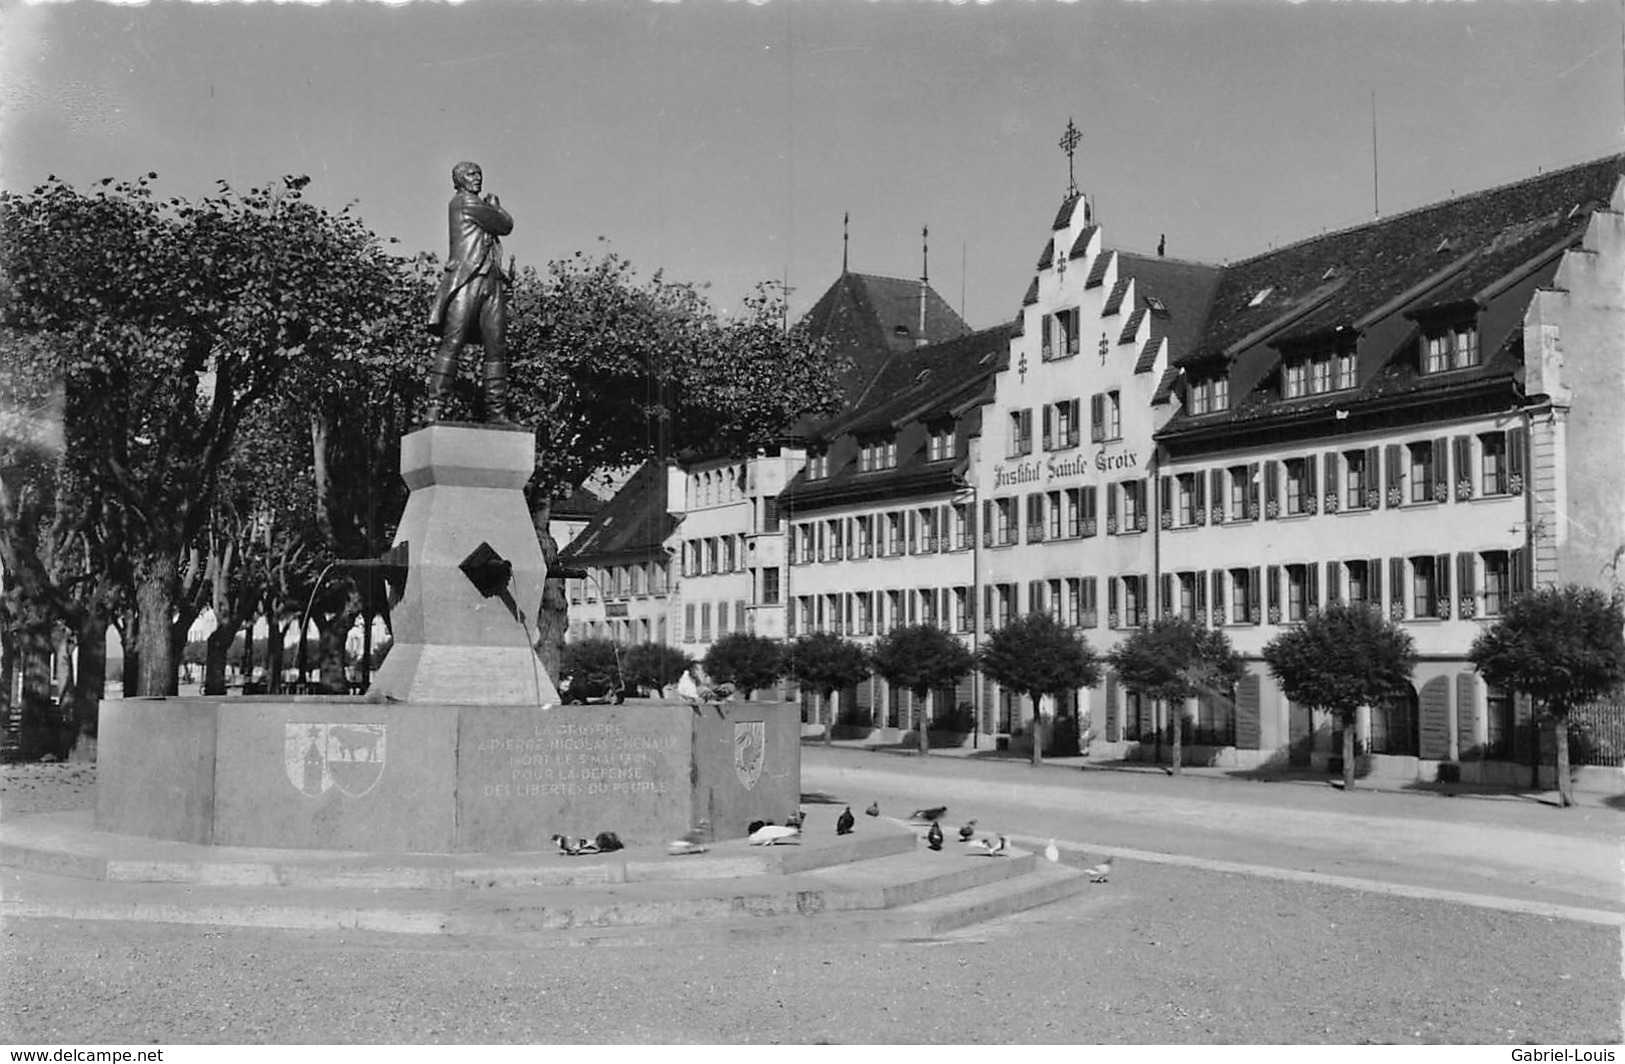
[0, 814, 1086, 945]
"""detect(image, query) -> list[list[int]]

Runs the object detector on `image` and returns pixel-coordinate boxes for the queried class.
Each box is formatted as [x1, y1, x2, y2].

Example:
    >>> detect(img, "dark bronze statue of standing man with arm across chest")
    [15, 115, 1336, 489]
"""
[427, 162, 514, 424]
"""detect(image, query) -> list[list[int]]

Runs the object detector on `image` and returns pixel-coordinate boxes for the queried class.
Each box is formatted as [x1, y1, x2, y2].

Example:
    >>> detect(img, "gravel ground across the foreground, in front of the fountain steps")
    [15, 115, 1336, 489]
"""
[0, 765, 1625, 1045]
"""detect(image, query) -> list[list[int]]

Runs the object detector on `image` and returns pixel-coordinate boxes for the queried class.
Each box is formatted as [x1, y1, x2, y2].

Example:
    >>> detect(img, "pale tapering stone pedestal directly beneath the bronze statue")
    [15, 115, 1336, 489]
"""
[367, 422, 559, 705]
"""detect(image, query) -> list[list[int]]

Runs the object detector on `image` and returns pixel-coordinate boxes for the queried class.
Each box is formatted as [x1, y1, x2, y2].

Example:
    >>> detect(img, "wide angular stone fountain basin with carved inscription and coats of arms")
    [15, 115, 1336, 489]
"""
[96, 697, 801, 853]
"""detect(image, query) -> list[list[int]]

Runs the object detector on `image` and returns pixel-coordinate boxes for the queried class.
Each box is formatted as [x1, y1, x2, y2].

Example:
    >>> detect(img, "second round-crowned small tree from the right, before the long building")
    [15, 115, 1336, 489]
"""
[1264, 603, 1417, 789]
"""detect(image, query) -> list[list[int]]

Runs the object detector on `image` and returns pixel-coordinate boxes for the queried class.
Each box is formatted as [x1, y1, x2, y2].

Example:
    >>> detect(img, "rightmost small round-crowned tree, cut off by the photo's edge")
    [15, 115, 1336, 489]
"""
[1467, 583, 1625, 807]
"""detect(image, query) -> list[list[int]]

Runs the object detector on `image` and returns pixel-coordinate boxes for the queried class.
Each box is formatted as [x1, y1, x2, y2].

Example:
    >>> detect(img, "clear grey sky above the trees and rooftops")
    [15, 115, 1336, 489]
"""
[0, 0, 1625, 328]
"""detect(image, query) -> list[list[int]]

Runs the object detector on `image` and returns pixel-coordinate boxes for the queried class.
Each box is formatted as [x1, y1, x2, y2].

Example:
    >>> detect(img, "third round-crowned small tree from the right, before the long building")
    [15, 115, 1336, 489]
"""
[1107, 617, 1246, 773]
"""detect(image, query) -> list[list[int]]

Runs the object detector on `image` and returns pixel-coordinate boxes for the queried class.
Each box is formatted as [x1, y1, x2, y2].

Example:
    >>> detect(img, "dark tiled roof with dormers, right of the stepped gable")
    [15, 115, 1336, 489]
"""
[1159, 156, 1625, 437]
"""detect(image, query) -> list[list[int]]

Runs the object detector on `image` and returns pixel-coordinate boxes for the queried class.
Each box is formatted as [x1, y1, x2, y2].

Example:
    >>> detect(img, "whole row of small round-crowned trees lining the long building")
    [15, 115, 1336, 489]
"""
[598, 585, 1625, 806]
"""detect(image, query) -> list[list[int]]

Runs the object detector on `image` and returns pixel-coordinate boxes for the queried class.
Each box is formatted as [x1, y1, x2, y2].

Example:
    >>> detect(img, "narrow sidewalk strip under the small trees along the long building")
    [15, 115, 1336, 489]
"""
[801, 733, 1625, 812]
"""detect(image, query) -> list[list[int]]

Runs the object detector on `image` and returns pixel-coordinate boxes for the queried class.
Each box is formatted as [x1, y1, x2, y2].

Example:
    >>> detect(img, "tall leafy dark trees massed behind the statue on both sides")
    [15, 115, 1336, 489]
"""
[0, 174, 843, 756]
